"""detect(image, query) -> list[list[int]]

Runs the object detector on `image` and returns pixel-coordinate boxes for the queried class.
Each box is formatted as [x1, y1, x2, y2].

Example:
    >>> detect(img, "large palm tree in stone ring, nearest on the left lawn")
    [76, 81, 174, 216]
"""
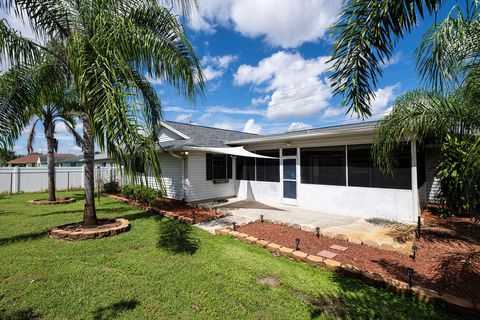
[0, 0, 204, 227]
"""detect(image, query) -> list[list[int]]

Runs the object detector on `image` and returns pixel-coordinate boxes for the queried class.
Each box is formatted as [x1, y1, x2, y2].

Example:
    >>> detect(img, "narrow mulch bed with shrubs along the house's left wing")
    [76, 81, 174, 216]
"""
[111, 194, 225, 223]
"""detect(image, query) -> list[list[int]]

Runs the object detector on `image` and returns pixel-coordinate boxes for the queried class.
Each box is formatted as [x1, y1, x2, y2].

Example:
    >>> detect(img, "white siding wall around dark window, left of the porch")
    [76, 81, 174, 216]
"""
[185, 151, 235, 201]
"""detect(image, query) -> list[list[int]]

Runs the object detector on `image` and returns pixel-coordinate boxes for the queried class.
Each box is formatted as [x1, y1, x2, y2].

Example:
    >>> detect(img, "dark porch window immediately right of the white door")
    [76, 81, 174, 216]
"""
[300, 146, 346, 186]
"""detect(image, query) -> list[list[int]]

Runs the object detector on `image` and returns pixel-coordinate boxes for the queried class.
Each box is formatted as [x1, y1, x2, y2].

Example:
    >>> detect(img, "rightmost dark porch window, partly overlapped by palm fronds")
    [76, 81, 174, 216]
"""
[348, 144, 412, 189]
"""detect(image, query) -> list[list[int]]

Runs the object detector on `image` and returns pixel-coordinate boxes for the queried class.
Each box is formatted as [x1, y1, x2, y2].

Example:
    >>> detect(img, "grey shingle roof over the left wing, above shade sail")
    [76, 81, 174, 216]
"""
[160, 121, 258, 149]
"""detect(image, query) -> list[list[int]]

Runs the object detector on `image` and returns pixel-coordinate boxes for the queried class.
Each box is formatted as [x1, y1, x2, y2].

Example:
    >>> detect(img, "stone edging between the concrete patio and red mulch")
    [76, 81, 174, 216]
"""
[238, 219, 413, 255]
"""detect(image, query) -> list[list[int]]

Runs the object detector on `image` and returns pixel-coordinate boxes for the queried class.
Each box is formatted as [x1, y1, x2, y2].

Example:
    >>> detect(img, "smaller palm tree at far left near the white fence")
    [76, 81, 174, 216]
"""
[0, 43, 82, 201]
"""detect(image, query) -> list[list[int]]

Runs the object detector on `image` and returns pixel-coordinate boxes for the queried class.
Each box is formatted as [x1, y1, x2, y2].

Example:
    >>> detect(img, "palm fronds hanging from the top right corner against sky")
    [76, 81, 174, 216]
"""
[331, 0, 480, 118]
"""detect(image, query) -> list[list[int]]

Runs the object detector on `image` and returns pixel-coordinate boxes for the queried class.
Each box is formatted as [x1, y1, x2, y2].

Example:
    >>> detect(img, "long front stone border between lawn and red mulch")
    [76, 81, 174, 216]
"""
[215, 226, 480, 314]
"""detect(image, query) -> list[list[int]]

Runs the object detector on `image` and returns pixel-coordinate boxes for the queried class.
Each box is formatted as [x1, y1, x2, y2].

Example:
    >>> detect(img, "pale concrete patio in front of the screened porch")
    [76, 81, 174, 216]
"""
[197, 198, 414, 247]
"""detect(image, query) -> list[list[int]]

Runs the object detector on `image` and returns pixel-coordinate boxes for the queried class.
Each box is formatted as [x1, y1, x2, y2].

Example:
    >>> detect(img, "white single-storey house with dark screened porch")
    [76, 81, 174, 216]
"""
[152, 121, 438, 222]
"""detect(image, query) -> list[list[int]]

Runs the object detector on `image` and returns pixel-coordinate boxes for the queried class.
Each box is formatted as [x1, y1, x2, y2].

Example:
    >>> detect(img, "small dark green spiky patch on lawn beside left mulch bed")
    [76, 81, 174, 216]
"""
[157, 219, 199, 254]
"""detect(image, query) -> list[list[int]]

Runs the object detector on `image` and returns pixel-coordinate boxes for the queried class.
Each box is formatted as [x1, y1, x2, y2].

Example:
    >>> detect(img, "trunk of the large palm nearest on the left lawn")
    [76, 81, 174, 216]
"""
[83, 115, 97, 228]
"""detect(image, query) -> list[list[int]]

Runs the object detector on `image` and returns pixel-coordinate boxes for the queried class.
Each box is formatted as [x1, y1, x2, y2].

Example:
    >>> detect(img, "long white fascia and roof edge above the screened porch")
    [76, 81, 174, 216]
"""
[227, 121, 378, 145]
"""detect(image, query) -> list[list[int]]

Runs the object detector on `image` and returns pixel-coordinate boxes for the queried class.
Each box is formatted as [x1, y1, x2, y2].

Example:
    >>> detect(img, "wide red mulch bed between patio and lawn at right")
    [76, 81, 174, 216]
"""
[238, 217, 480, 303]
